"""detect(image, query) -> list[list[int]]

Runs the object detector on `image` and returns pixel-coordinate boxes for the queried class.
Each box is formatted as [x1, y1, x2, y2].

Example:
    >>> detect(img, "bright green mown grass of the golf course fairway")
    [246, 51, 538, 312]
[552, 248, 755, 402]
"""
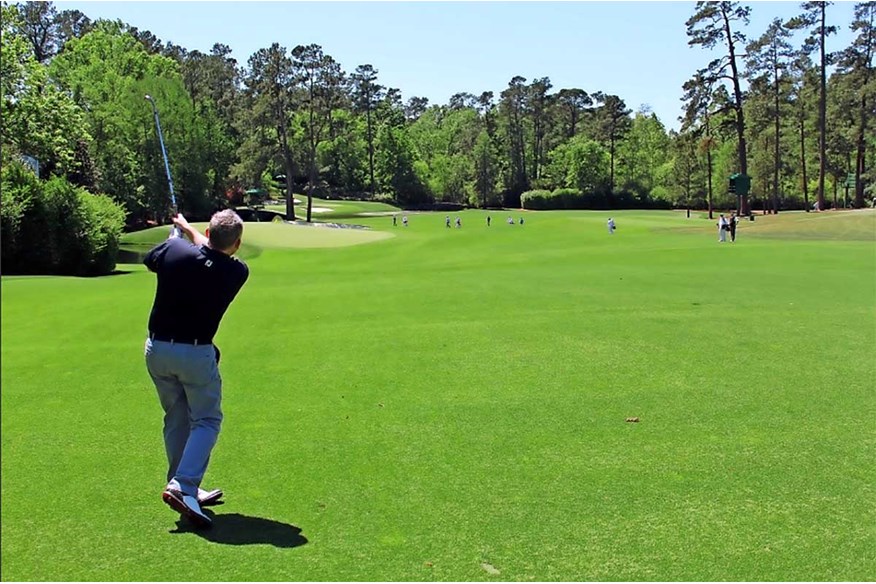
[0, 209, 876, 581]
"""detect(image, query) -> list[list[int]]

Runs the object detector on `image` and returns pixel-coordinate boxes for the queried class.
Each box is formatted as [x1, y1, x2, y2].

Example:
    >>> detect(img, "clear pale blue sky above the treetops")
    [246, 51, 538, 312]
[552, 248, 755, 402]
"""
[55, 0, 854, 129]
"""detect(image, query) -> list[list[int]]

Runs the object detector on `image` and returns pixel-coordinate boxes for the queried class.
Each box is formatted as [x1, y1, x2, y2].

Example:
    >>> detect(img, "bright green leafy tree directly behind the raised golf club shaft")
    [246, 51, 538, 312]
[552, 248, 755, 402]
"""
[49, 21, 212, 223]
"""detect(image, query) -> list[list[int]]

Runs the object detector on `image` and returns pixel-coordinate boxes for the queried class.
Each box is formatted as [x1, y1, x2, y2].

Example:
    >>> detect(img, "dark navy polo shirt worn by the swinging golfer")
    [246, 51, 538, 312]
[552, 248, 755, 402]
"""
[143, 237, 249, 344]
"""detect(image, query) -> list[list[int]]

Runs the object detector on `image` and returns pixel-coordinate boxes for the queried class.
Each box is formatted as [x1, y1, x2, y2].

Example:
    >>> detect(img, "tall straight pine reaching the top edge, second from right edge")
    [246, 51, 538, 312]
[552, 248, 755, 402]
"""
[788, 2, 836, 210]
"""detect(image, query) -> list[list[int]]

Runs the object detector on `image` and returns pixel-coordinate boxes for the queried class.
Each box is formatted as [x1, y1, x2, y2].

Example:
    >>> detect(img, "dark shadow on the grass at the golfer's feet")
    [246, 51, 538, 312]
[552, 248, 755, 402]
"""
[170, 509, 307, 548]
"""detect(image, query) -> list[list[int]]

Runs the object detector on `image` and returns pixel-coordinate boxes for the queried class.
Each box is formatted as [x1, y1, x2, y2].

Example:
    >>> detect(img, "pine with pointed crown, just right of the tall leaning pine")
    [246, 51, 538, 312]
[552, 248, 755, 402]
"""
[747, 18, 794, 213]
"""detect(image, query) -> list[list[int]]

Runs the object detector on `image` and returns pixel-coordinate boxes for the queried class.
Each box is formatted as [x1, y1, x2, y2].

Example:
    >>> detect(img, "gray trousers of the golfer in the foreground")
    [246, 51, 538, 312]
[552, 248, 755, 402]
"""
[145, 338, 222, 497]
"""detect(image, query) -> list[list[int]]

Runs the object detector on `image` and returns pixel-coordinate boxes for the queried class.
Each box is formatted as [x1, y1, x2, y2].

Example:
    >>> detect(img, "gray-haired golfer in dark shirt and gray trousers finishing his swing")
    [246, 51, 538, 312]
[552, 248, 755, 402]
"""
[143, 209, 249, 527]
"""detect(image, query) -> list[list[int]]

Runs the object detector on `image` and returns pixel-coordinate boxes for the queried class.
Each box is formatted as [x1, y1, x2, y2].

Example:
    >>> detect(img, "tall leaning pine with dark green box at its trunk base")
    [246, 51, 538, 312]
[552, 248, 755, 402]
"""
[686, 1, 751, 215]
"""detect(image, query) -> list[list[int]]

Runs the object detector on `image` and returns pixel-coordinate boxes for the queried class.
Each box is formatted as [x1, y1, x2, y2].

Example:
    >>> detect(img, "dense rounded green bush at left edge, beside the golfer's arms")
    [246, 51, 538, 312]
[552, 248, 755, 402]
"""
[0, 162, 125, 276]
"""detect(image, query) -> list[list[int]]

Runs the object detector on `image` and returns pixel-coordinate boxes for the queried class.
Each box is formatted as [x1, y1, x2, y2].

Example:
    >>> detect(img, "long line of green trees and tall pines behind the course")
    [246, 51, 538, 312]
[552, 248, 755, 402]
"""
[0, 2, 876, 236]
